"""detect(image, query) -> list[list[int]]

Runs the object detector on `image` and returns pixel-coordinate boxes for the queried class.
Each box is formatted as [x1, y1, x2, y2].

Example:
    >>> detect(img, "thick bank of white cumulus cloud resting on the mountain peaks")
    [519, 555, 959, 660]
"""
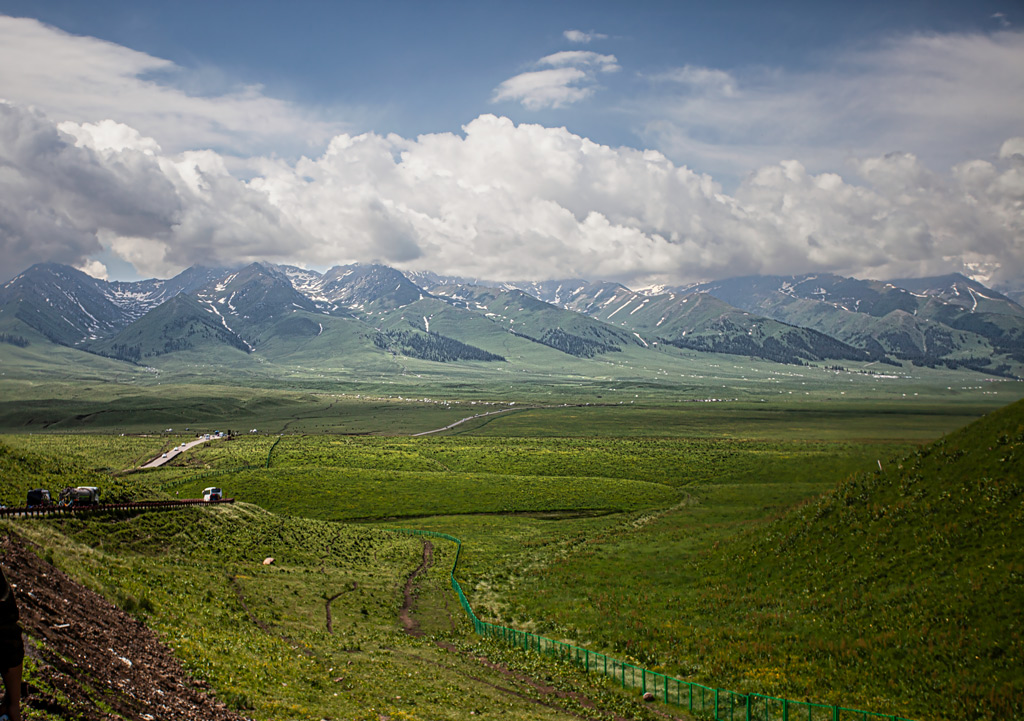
[0, 104, 1024, 286]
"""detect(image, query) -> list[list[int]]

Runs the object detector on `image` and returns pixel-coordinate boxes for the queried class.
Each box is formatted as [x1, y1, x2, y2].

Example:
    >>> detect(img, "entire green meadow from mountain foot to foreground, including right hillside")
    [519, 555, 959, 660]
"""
[0, 365, 1024, 721]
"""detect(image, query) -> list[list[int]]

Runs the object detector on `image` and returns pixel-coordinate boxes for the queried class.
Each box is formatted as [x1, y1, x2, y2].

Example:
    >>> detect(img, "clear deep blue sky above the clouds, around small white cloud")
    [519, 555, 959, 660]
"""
[6, 0, 1024, 162]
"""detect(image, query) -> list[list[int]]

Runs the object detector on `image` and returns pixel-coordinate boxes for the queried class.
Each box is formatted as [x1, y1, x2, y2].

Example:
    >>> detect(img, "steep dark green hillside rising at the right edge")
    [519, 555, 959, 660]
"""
[720, 402, 1024, 719]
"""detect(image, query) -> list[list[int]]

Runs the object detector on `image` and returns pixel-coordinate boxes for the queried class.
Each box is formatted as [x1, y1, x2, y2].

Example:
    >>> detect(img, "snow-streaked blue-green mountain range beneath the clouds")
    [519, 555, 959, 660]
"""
[0, 263, 1024, 377]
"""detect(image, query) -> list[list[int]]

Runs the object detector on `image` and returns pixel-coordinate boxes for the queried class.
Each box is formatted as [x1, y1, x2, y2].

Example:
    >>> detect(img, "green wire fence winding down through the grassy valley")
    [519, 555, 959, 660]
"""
[395, 528, 911, 721]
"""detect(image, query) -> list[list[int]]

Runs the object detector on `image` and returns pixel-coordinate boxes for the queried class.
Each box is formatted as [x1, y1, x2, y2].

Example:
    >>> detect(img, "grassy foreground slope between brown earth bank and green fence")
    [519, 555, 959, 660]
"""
[3, 505, 679, 721]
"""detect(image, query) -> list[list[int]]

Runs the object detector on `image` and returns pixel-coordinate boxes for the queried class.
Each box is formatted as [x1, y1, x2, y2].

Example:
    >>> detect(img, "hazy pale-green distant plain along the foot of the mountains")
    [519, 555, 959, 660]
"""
[0, 344, 1024, 439]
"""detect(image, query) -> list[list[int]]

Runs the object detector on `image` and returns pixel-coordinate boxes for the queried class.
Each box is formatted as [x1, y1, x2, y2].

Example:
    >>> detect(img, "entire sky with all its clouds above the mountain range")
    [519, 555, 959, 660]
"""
[0, 0, 1024, 288]
